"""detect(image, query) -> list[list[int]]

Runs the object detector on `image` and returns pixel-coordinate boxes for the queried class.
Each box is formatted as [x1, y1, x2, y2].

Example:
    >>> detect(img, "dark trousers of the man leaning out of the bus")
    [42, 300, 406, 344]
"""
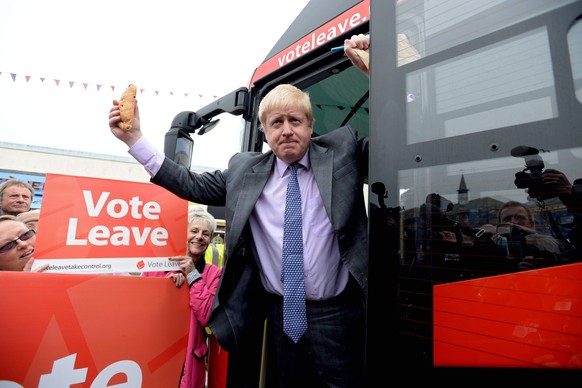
[266, 280, 365, 388]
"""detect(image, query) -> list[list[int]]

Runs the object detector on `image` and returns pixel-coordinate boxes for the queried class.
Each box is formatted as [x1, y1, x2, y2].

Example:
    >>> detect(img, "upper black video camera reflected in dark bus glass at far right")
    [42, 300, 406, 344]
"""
[511, 146, 557, 201]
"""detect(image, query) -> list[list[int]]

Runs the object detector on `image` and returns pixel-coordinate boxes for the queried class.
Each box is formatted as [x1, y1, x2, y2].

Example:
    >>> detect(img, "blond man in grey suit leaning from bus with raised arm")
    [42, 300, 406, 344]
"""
[109, 34, 368, 388]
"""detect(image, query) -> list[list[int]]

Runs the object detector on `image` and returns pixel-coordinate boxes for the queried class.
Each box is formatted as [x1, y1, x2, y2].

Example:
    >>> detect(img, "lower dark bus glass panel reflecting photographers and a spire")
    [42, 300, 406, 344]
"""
[399, 146, 582, 283]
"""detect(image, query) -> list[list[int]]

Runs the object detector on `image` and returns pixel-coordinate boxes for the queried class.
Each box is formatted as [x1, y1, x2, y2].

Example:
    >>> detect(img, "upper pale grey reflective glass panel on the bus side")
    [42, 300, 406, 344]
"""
[406, 28, 557, 144]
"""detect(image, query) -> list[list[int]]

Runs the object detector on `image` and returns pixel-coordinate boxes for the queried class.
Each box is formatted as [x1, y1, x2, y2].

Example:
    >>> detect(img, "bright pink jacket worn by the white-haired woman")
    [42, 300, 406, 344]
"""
[141, 260, 222, 388]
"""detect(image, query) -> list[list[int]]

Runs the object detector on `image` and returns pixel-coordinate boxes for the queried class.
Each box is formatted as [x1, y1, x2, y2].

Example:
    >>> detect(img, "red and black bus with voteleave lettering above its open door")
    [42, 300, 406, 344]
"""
[169, 0, 582, 386]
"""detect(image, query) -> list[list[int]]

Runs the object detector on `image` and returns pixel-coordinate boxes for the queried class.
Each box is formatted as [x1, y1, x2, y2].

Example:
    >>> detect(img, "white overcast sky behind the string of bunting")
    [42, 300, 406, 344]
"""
[0, 0, 308, 168]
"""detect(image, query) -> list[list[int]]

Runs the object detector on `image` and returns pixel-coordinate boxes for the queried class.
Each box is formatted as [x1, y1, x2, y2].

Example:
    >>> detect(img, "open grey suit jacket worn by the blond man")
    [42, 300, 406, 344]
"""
[152, 126, 368, 351]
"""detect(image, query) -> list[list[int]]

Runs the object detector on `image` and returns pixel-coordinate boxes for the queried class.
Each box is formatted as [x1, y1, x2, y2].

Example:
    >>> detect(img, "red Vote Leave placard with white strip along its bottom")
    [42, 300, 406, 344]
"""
[33, 174, 188, 273]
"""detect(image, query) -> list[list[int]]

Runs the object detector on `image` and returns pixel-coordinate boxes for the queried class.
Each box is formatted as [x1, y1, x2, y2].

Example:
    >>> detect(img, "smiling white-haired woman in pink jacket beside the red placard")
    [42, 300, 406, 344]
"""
[142, 211, 222, 388]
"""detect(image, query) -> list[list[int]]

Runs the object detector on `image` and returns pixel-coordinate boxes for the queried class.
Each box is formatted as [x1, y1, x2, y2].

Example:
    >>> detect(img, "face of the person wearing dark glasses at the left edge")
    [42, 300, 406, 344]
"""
[0, 220, 36, 271]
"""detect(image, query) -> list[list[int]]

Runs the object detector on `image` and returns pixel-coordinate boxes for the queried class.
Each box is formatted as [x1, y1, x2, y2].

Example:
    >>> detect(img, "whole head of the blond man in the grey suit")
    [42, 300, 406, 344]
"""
[259, 84, 314, 163]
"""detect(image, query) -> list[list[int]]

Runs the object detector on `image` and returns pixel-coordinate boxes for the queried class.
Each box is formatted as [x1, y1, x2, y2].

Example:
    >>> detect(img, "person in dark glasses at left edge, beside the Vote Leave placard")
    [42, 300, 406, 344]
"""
[0, 215, 48, 272]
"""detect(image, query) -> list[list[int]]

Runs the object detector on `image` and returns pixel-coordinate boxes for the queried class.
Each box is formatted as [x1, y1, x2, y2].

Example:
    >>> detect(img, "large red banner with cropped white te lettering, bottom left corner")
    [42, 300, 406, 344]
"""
[0, 271, 190, 388]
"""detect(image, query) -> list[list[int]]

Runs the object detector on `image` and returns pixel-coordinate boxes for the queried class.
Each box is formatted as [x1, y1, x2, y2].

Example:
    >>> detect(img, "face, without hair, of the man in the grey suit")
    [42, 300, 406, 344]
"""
[264, 109, 313, 163]
